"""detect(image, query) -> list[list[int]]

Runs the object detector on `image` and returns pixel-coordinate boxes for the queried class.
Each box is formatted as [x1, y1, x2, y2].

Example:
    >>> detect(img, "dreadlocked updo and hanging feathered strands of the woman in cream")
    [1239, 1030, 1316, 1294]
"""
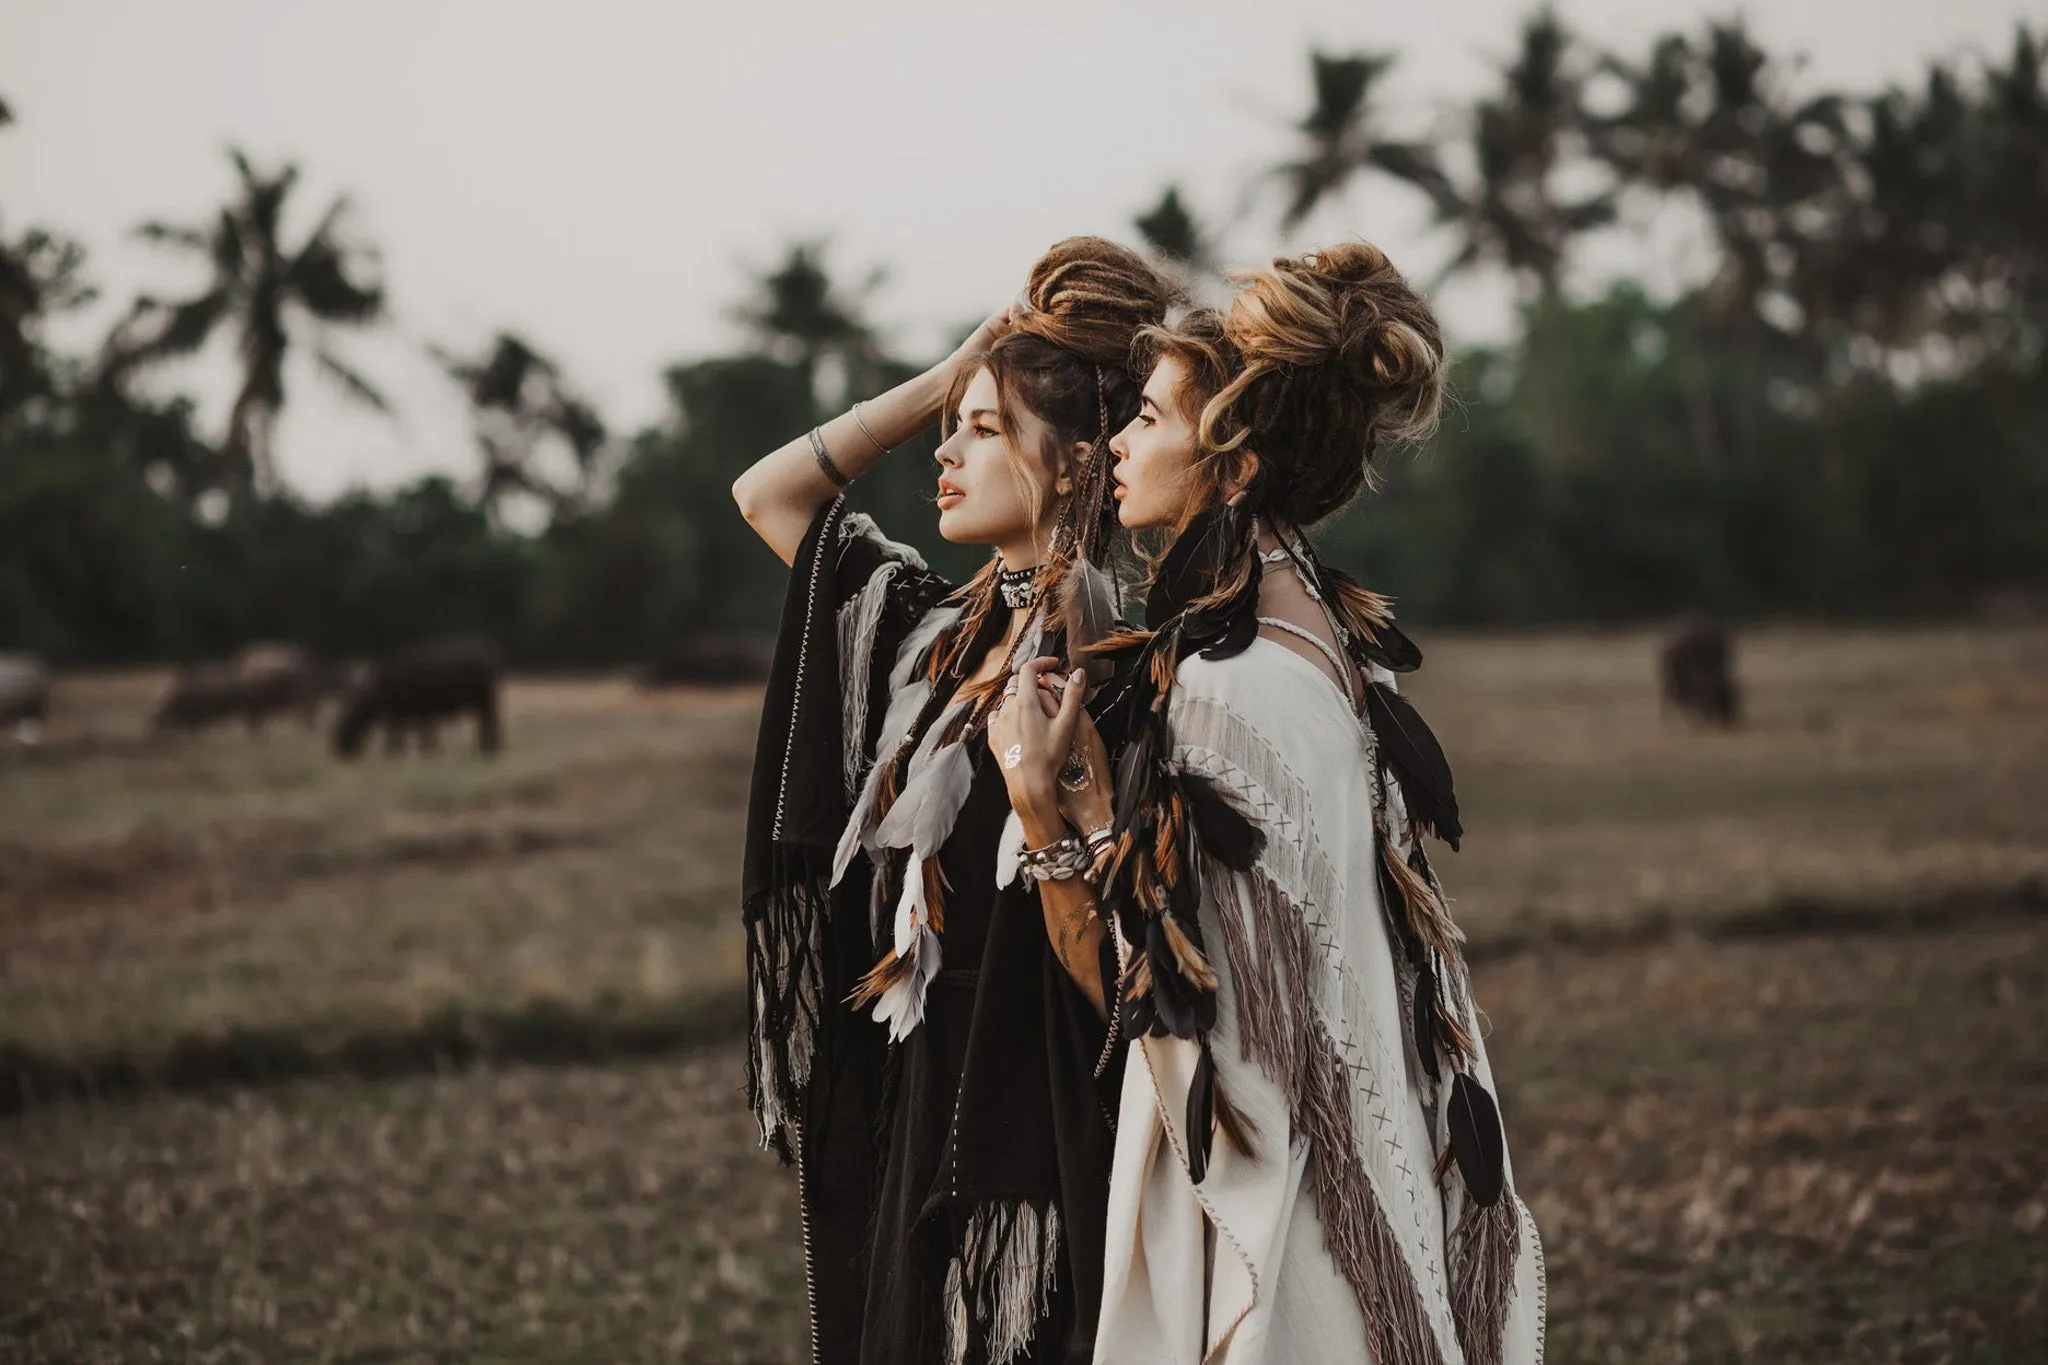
[1098, 241, 1475, 1179]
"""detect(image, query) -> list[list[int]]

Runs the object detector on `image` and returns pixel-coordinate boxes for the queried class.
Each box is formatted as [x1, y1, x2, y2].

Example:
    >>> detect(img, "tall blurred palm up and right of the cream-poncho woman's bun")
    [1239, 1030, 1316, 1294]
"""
[1438, 6, 1616, 299]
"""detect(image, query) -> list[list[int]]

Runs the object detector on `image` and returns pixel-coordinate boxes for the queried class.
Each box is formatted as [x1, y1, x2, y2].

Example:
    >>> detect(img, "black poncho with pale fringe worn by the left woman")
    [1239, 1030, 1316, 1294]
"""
[743, 501, 1122, 1365]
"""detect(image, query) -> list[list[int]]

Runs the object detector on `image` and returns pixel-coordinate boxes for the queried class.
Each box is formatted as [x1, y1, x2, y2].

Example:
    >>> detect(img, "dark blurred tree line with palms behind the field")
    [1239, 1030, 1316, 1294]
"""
[0, 10, 2048, 665]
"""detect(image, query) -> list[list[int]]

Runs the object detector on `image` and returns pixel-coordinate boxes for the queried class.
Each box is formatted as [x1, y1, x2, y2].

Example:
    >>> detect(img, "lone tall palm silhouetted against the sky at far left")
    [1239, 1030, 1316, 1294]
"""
[104, 149, 389, 497]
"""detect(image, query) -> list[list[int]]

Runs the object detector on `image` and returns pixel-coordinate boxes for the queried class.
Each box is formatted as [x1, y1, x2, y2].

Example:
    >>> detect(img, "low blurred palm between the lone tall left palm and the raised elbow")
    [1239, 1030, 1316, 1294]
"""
[432, 332, 608, 522]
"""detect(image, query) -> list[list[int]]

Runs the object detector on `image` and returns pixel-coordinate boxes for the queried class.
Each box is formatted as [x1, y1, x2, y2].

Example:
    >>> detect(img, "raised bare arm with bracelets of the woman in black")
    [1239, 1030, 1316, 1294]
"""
[733, 309, 1010, 565]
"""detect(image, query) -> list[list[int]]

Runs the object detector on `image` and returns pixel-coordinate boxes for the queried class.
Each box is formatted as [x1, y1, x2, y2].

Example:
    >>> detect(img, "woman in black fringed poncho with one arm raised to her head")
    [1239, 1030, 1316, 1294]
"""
[733, 237, 1169, 1365]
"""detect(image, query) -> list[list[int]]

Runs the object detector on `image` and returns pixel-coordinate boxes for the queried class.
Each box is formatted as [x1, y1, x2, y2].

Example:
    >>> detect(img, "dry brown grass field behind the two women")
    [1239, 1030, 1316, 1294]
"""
[0, 630, 2048, 1363]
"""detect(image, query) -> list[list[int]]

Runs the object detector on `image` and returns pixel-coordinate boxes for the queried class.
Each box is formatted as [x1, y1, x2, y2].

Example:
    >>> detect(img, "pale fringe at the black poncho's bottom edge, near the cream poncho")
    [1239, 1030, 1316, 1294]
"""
[944, 1203, 1063, 1365]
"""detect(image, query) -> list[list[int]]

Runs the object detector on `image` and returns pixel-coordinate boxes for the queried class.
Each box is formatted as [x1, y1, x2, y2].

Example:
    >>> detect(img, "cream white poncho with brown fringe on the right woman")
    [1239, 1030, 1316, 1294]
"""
[1096, 639, 1544, 1365]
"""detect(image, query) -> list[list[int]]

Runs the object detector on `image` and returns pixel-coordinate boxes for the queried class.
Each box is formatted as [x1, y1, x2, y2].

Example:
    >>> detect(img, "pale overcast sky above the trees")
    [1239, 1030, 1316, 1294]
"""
[0, 0, 2044, 497]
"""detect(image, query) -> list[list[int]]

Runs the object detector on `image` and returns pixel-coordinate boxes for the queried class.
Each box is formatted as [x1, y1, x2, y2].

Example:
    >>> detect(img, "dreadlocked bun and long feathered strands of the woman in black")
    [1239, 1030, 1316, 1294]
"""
[854, 237, 1178, 1019]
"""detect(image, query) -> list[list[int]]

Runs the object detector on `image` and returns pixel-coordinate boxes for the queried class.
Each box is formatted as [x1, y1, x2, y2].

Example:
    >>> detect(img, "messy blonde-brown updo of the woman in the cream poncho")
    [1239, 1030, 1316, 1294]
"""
[1198, 241, 1444, 526]
